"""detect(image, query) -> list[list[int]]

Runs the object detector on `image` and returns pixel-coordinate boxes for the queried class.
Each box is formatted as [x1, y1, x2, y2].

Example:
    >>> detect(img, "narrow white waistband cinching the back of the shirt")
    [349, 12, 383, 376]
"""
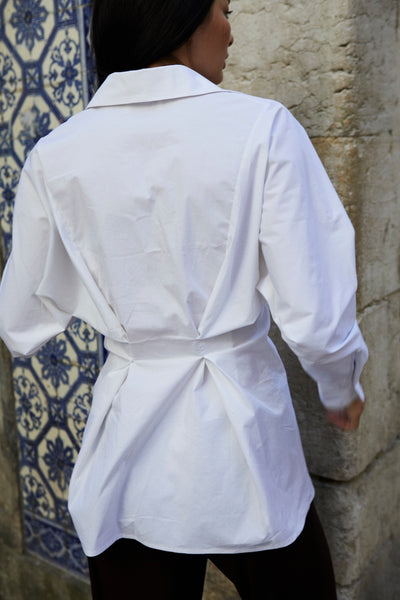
[104, 321, 267, 361]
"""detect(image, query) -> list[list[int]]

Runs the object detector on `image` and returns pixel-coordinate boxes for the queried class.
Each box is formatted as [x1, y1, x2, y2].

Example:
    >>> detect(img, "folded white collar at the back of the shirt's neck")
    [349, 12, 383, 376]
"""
[87, 65, 224, 108]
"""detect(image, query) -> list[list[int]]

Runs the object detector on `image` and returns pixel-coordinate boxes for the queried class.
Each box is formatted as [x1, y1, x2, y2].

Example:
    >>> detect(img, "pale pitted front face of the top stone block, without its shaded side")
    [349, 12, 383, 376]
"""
[224, 0, 357, 136]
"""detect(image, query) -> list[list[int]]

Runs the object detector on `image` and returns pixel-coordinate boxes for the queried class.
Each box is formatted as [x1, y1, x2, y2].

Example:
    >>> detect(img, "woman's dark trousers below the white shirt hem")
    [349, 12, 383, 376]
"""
[89, 504, 336, 600]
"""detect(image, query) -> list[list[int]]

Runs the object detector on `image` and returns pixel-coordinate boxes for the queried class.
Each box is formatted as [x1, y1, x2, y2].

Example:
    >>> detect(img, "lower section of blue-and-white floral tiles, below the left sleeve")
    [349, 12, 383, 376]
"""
[14, 332, 99, 574]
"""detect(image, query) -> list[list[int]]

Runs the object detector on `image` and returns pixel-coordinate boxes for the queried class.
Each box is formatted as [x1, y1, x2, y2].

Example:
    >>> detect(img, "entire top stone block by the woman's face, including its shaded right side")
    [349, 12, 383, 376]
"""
[224, 0, 400, 136]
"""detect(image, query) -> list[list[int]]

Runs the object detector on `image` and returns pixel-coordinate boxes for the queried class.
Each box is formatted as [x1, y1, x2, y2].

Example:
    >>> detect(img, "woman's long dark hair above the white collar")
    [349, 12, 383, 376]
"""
[91, 0, 213, 85]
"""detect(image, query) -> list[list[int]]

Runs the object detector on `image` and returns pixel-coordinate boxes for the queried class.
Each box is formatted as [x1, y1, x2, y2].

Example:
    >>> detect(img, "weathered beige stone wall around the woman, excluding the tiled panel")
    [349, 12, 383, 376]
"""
[0, 0, 400, 600]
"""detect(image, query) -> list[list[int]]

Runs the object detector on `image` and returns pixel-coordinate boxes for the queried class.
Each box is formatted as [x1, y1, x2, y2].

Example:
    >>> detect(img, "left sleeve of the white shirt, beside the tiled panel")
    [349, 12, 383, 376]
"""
[0, 150, 78, 356]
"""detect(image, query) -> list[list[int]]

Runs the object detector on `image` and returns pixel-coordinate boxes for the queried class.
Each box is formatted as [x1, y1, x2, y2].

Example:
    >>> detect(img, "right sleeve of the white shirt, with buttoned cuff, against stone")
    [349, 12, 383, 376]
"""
[258, 107, 368, 409]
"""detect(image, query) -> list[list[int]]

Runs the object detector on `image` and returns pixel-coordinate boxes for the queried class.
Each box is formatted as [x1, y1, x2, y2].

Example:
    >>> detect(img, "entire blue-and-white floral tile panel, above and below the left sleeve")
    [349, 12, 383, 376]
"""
[0, 0, 98, 577]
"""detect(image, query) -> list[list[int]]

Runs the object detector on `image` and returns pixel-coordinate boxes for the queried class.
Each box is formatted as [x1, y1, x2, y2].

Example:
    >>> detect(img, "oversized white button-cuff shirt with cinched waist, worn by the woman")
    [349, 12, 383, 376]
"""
[0, 66, 367, 555]
